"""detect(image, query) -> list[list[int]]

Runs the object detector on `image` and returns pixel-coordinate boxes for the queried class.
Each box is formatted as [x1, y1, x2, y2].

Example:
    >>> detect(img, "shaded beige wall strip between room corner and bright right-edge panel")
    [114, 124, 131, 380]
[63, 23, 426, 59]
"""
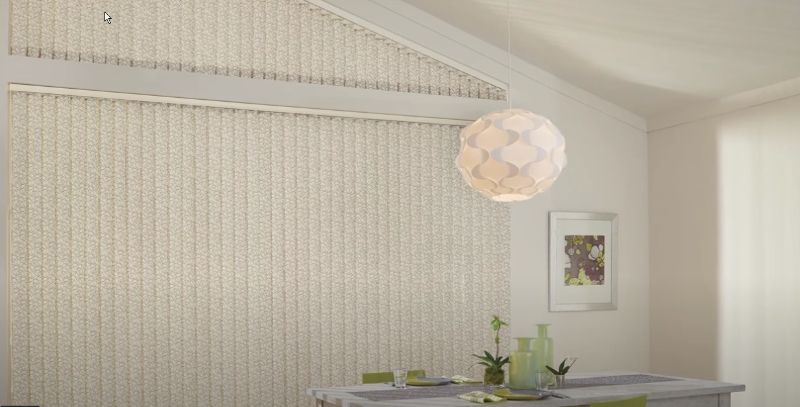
[648, 122, 718, 379]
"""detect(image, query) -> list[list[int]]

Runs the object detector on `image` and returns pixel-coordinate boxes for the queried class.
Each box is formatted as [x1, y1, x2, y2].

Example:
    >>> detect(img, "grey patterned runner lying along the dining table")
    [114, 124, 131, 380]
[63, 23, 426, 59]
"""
[350, 374, 680, 401]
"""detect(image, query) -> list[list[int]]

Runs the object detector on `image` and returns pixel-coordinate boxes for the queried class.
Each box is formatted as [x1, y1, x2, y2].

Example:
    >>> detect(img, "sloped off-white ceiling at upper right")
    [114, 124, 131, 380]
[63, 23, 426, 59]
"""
[406, 0, 800, 118]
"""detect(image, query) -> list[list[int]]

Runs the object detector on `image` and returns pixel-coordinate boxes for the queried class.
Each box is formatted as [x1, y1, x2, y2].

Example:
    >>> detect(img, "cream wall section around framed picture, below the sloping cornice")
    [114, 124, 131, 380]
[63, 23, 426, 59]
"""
[511, 79, 650, 372]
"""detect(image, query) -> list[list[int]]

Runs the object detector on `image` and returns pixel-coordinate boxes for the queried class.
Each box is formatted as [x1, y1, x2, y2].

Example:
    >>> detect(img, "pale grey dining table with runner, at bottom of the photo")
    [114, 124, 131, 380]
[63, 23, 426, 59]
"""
[306, 371, 745, 407]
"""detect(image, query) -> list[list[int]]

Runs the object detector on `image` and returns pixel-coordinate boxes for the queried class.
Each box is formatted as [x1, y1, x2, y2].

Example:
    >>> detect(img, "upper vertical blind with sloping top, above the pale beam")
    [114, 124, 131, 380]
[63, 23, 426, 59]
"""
[11, 0, 505, 99]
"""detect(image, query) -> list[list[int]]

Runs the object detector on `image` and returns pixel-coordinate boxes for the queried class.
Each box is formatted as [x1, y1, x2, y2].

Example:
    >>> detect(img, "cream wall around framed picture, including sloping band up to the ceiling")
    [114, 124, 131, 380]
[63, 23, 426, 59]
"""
[328, 0, 650, 371]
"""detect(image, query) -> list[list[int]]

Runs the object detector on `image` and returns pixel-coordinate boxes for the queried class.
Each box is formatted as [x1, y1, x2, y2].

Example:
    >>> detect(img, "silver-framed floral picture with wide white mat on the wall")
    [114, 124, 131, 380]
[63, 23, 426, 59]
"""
[550, 212, 617, 311]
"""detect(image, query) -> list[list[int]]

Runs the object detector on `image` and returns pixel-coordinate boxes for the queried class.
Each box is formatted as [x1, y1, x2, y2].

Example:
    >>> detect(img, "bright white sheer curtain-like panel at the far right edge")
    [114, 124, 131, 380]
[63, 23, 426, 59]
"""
[718, 98, 800, 406]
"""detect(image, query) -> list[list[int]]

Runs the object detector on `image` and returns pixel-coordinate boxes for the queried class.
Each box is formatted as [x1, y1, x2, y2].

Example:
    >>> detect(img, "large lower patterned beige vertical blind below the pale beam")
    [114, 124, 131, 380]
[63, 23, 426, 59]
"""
[10, 91, 509, 406]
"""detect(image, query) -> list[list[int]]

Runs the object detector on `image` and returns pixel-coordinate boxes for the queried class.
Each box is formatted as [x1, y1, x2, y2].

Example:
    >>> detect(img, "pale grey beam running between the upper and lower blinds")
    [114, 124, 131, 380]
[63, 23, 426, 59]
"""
[0, 56, 505, 124]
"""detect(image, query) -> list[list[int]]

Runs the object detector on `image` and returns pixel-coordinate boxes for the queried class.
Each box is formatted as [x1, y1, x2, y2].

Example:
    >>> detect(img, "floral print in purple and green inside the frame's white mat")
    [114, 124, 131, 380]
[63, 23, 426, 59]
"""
[564, 235, 606, 285]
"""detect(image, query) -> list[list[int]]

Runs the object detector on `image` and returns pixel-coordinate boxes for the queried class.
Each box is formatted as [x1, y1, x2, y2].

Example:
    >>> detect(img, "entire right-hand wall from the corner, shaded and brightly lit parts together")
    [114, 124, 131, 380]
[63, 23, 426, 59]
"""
[650, 96, 800, 407]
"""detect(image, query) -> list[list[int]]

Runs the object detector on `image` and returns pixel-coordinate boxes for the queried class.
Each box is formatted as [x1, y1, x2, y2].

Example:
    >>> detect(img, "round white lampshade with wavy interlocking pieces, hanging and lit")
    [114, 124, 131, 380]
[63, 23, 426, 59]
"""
[456, 109, 567, 202]
